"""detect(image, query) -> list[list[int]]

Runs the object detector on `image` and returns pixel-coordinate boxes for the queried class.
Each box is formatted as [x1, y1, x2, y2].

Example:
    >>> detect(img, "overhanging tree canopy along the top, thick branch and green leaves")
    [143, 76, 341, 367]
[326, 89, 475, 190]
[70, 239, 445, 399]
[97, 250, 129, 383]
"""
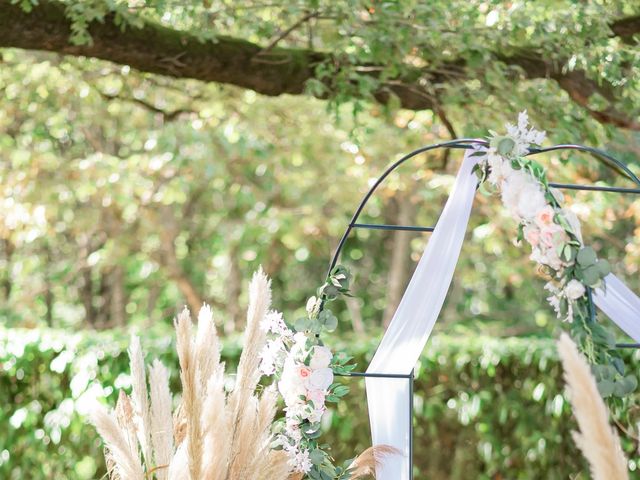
[0, 0, 640, 130]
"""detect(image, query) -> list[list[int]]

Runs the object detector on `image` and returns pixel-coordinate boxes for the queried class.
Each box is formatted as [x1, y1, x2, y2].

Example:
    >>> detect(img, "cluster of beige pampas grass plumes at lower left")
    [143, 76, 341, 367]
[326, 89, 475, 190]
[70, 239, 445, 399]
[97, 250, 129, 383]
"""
[92, 270, 291, 480]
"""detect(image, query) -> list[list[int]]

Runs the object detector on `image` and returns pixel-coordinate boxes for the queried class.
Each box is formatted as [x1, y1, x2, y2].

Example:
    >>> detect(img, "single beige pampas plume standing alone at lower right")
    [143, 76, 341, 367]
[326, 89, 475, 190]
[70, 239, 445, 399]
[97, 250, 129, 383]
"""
[558, 333, 629, 480]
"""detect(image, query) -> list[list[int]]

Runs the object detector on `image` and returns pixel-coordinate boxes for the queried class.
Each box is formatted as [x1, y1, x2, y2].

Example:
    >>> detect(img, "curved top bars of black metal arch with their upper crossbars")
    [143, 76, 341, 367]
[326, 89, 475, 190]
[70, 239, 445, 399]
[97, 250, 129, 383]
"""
[327, 138, 640, 278]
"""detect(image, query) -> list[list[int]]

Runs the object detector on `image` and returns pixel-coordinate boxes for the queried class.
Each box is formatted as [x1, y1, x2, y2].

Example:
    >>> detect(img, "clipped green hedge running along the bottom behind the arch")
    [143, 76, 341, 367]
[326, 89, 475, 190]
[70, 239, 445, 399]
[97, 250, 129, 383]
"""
[0, 329, 640, 480]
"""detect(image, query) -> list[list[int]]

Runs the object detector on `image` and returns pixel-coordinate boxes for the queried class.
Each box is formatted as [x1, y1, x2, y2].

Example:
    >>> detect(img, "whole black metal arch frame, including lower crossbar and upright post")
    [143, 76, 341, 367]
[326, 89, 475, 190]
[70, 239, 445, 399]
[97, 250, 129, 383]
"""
[327, 138, 640, 479]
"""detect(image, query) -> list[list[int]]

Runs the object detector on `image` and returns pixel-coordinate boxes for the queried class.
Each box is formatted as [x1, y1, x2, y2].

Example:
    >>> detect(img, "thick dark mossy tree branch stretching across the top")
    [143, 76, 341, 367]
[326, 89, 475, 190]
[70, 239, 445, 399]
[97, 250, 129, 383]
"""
[0, 0, 640, 130]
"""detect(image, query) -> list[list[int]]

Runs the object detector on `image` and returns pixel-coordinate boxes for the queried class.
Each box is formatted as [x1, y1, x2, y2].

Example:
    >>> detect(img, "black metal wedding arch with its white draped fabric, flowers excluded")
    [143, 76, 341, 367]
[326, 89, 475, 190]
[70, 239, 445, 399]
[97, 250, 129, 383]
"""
[320, 117, 640, 480]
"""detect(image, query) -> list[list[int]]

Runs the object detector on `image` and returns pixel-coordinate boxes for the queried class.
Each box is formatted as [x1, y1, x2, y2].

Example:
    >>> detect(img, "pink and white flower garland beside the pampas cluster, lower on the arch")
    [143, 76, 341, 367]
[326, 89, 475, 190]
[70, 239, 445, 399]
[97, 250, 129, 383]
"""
[260, 266, 354, 480]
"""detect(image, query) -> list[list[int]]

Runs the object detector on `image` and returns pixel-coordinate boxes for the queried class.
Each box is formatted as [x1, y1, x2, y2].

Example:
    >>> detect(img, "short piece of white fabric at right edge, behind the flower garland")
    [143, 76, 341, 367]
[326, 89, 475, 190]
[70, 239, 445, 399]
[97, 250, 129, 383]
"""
[593, 273, 640, 343]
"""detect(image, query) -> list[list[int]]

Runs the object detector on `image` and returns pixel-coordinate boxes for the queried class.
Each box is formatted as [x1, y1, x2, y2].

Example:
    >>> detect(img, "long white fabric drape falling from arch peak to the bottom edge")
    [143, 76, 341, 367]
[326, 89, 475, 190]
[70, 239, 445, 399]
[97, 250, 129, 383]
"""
[366, 150, 478, 480]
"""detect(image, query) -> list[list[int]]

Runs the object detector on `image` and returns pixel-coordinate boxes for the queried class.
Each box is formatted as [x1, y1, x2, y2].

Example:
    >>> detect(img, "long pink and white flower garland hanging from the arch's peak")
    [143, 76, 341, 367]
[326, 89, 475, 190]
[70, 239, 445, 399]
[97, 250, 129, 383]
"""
[472, 111, 637, 397]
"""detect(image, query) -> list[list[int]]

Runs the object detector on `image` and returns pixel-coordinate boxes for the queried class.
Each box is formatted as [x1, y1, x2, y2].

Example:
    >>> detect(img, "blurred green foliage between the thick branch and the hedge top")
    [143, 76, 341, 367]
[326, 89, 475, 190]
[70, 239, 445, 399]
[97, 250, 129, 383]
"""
[0, 50, 640, 335]
